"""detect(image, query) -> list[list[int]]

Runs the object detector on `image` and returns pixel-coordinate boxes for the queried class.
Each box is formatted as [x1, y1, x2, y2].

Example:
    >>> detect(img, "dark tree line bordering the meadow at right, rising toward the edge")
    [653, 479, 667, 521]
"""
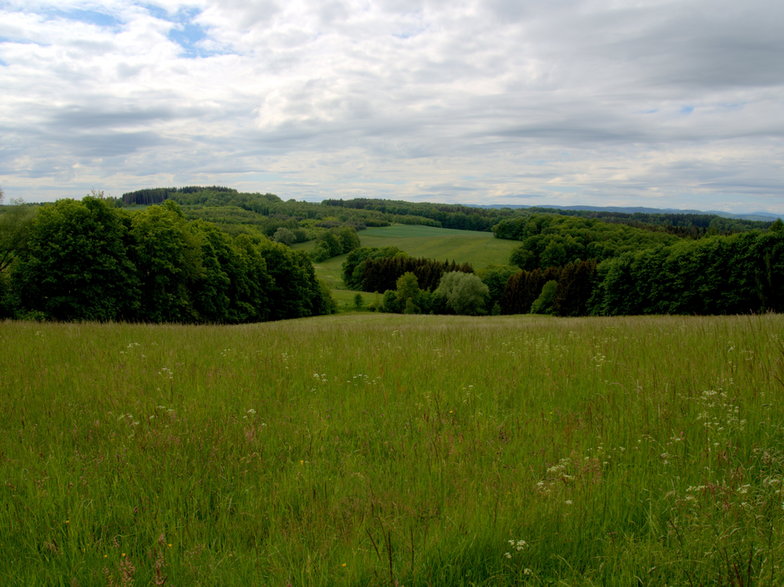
[500, 223, 784, 316]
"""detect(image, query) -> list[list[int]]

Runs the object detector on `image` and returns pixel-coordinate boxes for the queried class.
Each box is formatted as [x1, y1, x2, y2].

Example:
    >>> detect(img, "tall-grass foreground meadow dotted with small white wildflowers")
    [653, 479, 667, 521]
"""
[0, 313, 784, 585]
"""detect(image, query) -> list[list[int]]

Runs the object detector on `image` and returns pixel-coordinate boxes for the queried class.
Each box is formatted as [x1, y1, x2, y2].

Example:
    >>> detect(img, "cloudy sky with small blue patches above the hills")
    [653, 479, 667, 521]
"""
[0, 0, 784, 214]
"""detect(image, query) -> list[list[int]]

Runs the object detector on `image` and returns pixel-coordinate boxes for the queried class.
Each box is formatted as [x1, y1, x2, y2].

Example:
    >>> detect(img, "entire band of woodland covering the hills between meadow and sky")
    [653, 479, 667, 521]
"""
[0, 186, 784, 324]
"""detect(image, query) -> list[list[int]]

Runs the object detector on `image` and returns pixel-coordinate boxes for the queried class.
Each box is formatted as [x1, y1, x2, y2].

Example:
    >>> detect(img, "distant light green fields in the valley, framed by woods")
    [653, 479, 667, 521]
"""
[302, 224, 520, 309]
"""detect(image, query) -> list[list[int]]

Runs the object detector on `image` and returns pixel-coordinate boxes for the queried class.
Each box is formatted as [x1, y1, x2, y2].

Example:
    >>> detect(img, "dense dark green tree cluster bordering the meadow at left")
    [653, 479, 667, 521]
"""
[2, 197, 332, 323]
